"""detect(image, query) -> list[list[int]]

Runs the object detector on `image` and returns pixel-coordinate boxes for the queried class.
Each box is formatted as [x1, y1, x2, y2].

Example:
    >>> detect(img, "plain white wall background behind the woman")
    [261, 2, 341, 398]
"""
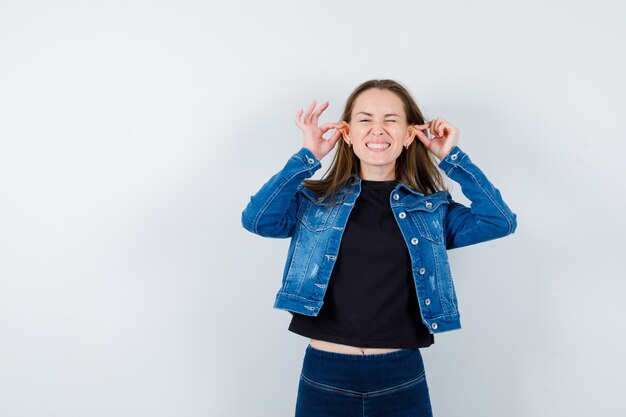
[0, 0, 626, 417]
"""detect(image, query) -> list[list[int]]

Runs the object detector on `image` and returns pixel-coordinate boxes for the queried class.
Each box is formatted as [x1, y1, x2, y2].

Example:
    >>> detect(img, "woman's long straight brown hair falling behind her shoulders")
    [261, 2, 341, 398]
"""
[303, 80, 446, 201]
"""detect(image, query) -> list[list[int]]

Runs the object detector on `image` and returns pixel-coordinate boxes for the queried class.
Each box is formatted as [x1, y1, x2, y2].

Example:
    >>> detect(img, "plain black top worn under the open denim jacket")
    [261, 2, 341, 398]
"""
[289, 180, 435, 349]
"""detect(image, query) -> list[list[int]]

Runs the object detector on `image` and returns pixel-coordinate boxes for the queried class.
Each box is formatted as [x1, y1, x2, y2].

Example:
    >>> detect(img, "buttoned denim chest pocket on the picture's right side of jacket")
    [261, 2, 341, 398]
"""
[404, 198, 449, 244]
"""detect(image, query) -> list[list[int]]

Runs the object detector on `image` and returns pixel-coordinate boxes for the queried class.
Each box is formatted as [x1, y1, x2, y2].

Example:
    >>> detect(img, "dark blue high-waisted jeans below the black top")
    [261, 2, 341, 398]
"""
[296, 345, 432, 417]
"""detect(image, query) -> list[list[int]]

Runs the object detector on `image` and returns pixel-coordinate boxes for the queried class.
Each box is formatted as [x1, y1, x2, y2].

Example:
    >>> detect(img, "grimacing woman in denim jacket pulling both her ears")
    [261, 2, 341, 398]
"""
[242, 80, 517, 417]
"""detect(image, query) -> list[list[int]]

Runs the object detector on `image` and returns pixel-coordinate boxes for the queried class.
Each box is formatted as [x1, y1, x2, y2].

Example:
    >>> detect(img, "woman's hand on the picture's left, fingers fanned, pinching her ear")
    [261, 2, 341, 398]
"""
[296, 100, 342, 160]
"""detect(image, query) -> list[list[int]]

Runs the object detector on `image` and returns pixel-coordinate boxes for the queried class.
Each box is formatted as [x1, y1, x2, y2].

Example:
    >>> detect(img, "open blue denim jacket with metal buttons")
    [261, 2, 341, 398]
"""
[241, 146, 517, 334]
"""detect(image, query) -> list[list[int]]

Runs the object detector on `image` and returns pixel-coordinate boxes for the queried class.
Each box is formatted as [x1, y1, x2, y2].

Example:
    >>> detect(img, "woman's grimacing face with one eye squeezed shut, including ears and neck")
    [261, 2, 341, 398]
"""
[342, 88, 413, 181]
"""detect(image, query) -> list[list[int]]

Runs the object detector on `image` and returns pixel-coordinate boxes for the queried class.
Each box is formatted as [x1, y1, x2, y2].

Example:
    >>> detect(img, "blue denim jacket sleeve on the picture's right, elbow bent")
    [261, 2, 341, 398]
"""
[439, 146, 517, 249]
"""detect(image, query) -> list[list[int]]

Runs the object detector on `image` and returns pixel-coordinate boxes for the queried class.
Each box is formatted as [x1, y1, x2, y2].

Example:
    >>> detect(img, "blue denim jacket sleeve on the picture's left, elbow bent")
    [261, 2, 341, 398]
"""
[241, 147, 322, 238]
